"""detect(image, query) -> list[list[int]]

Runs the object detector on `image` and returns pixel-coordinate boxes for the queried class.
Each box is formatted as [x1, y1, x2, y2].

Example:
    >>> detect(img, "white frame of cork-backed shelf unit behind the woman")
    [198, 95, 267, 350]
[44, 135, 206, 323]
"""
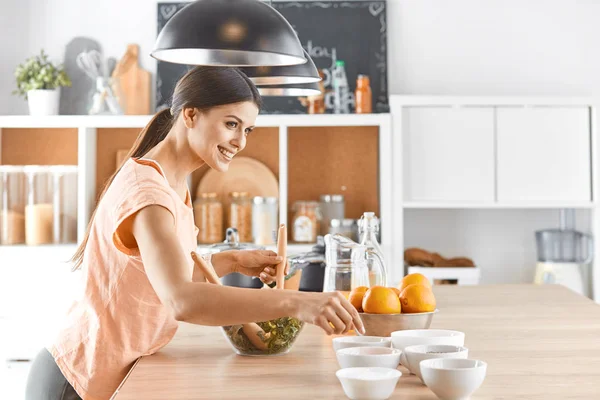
[0, 114, 393, 276]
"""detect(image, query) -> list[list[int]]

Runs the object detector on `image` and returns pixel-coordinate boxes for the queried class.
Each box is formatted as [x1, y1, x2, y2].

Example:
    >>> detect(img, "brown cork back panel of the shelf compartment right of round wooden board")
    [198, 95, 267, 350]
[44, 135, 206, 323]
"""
[288, 127, 379, 224]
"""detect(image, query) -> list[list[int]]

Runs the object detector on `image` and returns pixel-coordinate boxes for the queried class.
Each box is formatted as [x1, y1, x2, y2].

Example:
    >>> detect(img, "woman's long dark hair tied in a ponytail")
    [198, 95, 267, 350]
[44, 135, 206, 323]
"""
[71, 66, 262, 269]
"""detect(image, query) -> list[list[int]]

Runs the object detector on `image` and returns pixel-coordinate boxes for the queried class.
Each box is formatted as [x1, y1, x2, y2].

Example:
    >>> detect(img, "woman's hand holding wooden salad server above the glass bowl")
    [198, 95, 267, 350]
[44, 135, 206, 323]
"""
[232, 250, 289, 285]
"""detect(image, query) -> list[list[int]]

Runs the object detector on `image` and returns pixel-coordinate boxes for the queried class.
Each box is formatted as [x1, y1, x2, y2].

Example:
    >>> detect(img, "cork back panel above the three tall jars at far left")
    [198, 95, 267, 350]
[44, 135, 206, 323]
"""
[0, 128, 77, 165]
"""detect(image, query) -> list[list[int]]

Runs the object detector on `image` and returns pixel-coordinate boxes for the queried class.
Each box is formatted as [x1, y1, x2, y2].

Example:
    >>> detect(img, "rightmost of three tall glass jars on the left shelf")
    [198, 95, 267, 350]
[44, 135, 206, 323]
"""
[50, 165, 77, 244]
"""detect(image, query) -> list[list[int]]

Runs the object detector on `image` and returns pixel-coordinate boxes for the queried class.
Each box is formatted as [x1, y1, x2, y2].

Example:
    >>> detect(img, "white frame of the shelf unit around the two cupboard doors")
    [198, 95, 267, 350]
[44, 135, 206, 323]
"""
[390, 95, 600, 302]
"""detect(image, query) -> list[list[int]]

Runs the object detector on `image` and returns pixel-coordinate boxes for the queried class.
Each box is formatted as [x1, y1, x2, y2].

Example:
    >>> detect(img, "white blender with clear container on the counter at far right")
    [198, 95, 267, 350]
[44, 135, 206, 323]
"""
[534, 210, 593, 296]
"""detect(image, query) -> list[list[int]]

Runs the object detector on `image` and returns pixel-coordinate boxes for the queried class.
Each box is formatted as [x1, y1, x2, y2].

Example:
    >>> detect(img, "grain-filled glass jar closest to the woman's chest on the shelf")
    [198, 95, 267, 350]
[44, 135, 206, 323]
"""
[194, 193, 224, 244]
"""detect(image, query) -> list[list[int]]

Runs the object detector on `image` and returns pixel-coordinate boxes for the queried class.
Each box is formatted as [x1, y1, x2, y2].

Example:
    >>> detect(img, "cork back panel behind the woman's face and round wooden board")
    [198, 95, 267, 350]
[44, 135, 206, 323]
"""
[190, 128, 279, 202]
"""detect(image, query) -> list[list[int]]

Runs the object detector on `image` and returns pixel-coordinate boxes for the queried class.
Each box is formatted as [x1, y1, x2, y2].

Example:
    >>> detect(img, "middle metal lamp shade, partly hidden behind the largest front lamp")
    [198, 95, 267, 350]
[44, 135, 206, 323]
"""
[242, 50, 321, 86]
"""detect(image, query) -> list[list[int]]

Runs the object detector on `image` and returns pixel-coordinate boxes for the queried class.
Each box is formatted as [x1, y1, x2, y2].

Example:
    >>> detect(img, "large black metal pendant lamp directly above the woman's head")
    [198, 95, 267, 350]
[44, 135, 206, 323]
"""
[151, 0, 306, 67]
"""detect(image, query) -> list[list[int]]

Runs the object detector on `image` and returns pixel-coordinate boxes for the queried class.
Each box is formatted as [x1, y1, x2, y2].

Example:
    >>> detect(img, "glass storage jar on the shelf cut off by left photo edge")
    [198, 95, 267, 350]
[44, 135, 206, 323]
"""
[0, 165, 27, 245]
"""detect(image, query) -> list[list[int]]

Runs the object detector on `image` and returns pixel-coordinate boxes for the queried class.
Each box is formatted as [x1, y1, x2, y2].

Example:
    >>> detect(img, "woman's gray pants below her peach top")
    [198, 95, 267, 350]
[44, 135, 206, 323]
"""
[25, 349, 81, 400]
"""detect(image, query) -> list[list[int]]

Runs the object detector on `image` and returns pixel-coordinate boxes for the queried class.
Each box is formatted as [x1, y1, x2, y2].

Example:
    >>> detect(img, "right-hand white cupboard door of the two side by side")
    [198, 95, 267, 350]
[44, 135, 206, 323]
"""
[497, 107, 591, 203]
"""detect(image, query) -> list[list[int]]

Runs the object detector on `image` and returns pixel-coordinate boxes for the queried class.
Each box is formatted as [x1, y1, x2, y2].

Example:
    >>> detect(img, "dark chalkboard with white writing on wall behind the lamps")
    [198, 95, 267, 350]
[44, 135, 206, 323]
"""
[156, 0, 389, 114]
